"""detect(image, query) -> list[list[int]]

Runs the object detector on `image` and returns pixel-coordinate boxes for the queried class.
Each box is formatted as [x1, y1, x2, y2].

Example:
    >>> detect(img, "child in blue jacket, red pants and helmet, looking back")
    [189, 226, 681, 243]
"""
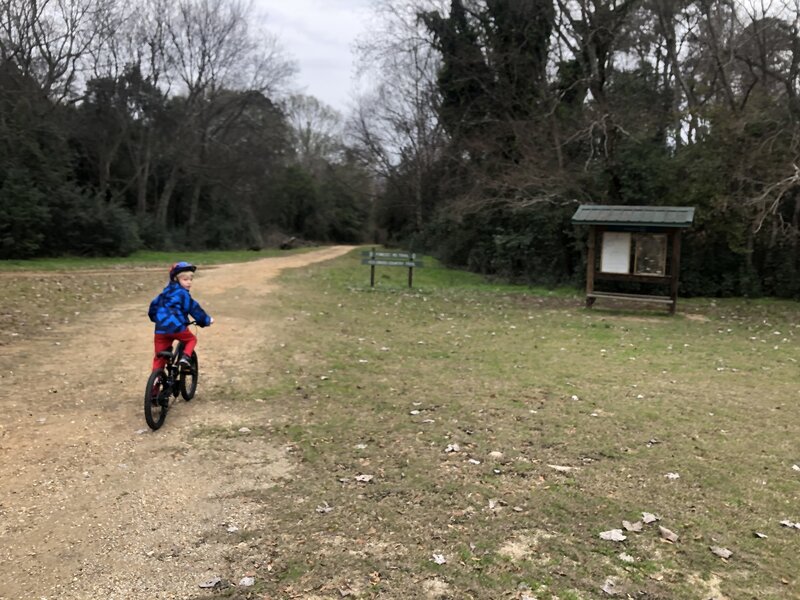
[147, 261, 214, 371]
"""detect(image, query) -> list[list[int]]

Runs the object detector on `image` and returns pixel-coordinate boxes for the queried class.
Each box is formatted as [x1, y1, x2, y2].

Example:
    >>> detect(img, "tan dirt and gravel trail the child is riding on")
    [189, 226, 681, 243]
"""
[0, 246, 351, 600]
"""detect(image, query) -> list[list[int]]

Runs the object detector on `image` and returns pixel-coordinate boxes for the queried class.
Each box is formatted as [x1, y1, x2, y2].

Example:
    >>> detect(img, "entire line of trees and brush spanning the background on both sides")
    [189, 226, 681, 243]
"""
[6, 0, 800, 297]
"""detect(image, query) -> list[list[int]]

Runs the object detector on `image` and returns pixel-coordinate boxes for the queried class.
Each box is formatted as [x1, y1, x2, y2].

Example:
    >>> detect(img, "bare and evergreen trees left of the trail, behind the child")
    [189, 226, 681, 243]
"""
[0, 0, 372, 258]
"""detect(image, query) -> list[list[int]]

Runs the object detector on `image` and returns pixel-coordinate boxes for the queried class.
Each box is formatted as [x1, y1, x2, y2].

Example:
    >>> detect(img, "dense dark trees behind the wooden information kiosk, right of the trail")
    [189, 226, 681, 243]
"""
[354, 0, 800, 297]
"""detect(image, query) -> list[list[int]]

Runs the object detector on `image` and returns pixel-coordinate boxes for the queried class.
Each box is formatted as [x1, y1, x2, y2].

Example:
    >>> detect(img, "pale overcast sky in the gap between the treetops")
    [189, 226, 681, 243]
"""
[253, 0, 371, 112]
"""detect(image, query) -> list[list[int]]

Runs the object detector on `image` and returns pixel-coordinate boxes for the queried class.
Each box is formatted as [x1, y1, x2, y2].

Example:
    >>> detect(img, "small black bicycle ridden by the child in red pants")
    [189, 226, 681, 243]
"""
[144, 321, 200, 431]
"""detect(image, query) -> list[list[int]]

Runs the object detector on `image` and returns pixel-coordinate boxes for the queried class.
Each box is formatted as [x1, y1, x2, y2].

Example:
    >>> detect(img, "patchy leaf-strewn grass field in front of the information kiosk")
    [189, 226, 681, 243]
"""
[200, 254, 800, 599]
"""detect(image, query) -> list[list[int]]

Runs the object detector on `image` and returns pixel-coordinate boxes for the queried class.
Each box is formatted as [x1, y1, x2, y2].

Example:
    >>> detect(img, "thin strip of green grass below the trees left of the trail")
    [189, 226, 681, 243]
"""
[0, 248, 313, 271]
